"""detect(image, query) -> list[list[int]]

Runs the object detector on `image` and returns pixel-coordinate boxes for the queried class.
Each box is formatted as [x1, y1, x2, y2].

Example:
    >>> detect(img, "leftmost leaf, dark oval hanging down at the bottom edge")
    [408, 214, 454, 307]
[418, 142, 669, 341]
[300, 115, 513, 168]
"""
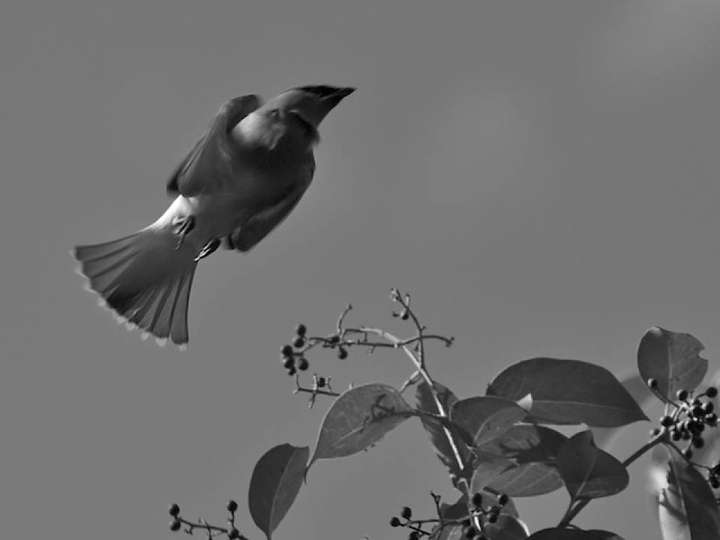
[248, 444, 310, 540]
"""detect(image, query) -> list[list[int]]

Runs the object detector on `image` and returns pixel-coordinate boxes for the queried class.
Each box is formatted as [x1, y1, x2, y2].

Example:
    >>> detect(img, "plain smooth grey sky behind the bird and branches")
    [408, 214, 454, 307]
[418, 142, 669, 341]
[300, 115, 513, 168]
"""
[0, 0, 720, 540]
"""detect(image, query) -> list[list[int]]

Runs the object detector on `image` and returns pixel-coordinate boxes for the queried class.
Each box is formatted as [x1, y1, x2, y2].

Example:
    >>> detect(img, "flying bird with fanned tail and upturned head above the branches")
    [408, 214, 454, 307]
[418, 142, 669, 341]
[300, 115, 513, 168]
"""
[72, 85, 355, 349]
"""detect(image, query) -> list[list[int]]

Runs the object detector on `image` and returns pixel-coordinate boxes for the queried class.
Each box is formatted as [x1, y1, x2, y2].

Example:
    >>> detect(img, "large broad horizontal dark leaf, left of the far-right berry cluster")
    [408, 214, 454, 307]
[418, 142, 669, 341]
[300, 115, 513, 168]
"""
[487, 358, 647, 427]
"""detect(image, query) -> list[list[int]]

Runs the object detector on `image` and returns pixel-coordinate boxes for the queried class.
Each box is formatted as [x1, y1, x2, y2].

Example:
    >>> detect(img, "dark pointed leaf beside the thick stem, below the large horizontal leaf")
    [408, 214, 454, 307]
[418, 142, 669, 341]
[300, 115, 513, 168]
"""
[557, 430, 629, 499]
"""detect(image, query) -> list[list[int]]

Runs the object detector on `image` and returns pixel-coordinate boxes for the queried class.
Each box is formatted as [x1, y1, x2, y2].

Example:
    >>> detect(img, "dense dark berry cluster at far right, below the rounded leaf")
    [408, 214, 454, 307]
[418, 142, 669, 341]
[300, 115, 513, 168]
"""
[647, 379, 718, 459]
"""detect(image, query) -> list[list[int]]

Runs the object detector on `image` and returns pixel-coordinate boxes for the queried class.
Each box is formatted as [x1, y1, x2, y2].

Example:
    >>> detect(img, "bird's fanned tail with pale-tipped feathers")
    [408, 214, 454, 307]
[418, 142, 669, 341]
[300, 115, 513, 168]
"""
[73, 226, 197, 346]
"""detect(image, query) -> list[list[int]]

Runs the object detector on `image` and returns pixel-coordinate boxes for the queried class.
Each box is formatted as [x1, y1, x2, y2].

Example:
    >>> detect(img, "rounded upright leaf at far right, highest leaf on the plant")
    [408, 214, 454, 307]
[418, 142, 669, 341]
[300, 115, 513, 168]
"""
[638, 326, 708, 401]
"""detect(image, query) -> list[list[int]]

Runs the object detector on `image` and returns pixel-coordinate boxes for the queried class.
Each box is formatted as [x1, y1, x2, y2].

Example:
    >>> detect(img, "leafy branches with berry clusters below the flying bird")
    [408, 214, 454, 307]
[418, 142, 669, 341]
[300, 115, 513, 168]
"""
[170, 290, 720, 540]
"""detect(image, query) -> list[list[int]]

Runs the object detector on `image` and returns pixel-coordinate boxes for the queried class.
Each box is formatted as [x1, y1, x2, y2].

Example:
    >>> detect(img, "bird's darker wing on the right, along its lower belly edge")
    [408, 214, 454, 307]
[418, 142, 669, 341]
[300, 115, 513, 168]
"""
[223, 155, 315, 251]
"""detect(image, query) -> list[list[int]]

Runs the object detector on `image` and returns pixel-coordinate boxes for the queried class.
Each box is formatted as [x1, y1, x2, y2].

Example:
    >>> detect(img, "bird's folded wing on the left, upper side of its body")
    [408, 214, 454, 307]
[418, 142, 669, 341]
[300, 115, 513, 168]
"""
[167, 94, 261, 197]
